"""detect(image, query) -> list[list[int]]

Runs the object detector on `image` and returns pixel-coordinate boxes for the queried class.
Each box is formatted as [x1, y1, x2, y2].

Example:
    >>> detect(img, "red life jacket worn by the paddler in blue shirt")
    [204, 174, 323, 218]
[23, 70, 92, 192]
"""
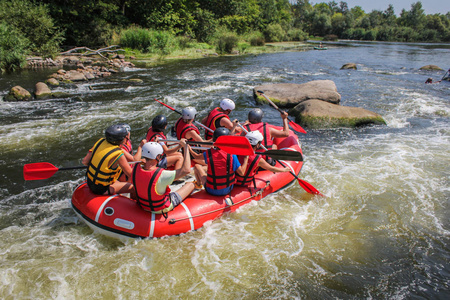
[205, 149, 235, 190]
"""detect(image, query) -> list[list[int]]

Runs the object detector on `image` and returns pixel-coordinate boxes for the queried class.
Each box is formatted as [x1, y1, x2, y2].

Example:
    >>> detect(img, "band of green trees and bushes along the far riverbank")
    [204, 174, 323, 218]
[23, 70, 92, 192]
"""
[0, 0, 450, 72]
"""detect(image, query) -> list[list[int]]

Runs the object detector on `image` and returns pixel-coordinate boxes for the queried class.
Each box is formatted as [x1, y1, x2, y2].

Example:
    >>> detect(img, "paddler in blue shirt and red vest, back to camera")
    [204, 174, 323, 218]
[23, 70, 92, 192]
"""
[194, 127, 248, 196]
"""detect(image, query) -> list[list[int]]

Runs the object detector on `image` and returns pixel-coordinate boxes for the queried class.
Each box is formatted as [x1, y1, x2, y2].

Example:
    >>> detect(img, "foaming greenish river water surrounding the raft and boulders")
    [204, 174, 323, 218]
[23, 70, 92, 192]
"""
[0, 41, 450, 299]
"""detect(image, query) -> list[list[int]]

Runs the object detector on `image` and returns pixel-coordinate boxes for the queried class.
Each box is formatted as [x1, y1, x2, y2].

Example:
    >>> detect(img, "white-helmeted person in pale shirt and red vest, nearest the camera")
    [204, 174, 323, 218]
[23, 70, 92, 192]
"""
[132, 139, 195, 215]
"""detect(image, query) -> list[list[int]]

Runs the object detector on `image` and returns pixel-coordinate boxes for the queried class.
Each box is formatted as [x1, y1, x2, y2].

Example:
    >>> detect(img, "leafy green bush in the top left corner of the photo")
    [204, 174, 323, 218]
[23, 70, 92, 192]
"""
[0, 0, 63, 57]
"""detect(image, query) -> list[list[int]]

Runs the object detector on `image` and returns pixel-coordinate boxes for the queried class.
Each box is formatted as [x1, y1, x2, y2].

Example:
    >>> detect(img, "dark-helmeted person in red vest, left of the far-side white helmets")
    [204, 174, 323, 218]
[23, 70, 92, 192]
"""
[145, 115, 183, 170]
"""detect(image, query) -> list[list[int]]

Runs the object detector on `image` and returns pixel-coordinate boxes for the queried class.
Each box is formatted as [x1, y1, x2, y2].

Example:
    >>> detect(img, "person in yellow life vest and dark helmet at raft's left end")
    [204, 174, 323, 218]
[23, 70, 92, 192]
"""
[82, 124, 133, 195]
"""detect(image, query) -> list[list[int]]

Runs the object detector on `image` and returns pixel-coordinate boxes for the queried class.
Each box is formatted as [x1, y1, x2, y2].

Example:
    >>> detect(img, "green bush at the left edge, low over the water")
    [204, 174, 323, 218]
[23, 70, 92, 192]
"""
[0, 22, 29, 72]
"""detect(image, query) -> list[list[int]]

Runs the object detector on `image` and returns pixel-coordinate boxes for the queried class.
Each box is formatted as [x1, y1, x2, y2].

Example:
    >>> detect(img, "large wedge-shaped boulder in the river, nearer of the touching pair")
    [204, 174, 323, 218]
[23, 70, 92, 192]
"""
[289, 100, 386, 128]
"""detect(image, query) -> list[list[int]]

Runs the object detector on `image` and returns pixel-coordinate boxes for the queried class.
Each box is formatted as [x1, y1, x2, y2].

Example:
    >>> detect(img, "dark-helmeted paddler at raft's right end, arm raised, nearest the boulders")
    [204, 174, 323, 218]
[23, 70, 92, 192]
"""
[242, 108, 289, 165]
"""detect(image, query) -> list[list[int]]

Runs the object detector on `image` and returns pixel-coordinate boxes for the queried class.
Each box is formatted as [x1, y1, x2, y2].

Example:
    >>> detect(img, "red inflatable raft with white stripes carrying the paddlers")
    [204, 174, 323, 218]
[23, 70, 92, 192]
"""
[72, 133, 303, 239]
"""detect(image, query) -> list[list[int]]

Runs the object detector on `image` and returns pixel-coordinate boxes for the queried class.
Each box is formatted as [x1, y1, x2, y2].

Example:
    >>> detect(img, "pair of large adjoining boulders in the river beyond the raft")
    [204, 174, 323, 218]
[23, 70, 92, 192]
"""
[253, 80, 386, 128]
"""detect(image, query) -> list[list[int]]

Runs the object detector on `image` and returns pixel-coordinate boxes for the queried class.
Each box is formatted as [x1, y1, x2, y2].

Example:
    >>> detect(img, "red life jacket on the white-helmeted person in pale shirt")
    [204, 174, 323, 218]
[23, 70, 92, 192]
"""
[133, 164, 173, 214]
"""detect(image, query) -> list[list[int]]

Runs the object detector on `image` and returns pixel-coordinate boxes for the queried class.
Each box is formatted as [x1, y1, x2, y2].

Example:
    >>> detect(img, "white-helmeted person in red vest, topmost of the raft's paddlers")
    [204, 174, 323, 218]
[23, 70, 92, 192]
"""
[201, 98, 239, 140]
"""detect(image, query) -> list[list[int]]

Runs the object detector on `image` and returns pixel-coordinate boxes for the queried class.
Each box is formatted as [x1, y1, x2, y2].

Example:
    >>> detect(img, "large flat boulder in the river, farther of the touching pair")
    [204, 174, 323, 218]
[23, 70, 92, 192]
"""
[253, 80, 341, 107]
